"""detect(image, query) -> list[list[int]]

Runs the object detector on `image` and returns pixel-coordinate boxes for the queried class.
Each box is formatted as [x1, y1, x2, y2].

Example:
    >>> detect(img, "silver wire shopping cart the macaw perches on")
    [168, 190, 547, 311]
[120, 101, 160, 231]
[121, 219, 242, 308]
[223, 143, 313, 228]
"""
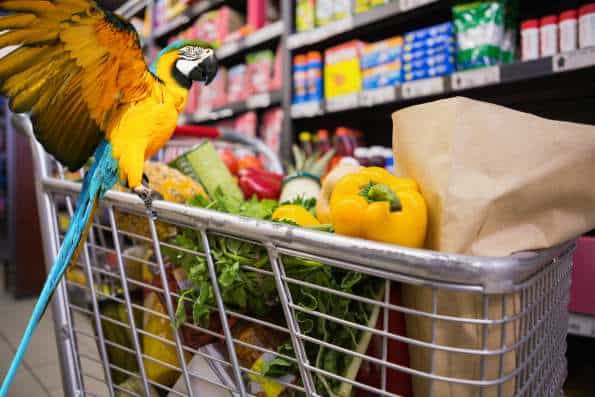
[16, 112, 574, 397]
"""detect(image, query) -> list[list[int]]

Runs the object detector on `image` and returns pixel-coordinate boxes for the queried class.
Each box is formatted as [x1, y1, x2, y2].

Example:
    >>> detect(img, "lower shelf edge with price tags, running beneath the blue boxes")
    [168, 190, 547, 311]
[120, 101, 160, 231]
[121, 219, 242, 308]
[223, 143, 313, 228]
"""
[291, 47, 595, 119]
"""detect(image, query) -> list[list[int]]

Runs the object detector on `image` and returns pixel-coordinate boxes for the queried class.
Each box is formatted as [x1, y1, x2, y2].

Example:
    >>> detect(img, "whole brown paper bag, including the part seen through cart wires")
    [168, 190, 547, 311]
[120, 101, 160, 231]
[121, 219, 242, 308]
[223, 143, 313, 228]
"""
[393, 98, 595, 397]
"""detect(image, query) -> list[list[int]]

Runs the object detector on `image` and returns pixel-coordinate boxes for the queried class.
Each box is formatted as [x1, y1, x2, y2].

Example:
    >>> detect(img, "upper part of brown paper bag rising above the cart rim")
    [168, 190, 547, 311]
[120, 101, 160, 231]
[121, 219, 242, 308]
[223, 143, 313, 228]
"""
[393, 97, 595, 255]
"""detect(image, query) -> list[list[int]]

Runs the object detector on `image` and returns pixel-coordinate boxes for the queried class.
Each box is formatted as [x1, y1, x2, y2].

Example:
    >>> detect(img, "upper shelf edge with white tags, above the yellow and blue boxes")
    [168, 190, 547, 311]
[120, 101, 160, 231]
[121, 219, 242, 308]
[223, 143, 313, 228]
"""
[287, 0, 440, 50]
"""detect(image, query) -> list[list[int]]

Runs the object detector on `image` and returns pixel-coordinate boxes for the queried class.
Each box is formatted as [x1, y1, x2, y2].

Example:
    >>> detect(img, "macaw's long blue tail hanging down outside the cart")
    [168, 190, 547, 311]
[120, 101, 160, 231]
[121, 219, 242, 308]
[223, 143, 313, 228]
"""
[0, 141, 118, 397]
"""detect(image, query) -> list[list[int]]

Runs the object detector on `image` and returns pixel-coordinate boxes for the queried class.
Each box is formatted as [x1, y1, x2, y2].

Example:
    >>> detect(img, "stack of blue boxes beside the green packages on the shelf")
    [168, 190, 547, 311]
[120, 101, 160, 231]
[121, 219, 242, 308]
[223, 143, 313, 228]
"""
[402, 22, 456, 81]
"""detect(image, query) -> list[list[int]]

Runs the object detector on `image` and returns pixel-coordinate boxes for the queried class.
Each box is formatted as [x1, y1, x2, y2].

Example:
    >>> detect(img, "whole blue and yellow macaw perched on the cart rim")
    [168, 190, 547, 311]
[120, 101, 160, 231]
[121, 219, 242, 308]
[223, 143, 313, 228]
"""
[0, 0, 217, 397]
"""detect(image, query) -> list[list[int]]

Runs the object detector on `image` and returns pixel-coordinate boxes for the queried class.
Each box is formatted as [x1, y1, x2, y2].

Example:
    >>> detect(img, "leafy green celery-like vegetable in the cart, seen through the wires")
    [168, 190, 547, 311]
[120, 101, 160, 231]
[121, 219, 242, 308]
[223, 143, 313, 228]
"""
[164, 187, 383, 397]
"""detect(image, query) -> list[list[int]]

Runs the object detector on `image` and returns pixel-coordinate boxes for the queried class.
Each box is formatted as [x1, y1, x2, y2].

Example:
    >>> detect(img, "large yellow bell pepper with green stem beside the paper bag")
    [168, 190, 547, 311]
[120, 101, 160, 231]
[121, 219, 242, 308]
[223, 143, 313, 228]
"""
[330, 167, 427, 248]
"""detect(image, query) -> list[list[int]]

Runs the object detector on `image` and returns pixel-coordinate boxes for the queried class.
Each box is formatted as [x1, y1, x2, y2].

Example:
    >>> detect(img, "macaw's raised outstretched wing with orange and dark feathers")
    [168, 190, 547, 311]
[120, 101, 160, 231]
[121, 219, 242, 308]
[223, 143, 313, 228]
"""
[0, 0, 160, 170]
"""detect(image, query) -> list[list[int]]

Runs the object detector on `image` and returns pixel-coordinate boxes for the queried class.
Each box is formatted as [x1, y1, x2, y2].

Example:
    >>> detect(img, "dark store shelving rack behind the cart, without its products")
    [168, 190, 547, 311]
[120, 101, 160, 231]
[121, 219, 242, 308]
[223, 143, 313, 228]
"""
[119, 0, 595, 158]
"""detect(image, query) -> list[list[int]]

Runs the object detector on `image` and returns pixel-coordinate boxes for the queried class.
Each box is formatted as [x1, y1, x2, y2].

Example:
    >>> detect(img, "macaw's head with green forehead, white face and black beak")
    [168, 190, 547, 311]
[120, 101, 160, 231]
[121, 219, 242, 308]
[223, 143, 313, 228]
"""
[150, 40, 218, 88]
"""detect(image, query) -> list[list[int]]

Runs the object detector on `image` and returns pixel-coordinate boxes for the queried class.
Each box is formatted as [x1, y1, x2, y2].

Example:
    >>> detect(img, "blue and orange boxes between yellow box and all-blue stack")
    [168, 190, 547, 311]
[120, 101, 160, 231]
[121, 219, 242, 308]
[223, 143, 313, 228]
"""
[360, 36, 403, 91]
